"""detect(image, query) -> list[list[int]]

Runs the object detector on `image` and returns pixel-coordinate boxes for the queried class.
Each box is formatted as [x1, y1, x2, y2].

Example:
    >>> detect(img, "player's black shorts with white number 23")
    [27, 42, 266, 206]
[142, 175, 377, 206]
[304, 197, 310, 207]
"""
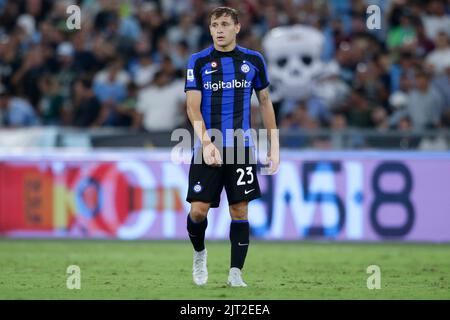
[186, 147, 261, 208]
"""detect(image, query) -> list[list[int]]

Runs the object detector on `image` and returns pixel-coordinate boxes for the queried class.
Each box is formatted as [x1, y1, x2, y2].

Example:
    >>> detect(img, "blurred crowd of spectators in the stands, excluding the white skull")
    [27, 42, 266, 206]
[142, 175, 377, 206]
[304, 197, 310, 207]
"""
[0, 0, 450, 136]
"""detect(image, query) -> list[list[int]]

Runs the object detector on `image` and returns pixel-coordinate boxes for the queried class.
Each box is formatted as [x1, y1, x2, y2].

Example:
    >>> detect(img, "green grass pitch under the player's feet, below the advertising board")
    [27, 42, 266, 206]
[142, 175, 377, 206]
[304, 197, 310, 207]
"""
[0, 239, 450, 300]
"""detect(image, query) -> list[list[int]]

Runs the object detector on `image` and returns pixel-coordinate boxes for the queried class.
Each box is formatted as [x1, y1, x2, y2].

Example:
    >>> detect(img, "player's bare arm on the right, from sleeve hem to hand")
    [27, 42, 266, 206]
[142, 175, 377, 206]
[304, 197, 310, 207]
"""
[256, 87, 280, 174]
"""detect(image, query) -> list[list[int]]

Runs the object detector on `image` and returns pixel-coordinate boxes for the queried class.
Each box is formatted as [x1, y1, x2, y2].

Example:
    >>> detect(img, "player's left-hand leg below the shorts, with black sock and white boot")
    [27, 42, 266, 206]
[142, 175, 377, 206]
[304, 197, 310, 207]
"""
[187, 201, 210, 285]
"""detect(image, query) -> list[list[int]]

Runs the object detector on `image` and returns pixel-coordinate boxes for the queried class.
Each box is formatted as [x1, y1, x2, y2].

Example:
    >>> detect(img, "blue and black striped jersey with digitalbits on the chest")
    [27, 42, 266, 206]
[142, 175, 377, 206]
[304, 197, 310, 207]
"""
[185, 46, 269, 146]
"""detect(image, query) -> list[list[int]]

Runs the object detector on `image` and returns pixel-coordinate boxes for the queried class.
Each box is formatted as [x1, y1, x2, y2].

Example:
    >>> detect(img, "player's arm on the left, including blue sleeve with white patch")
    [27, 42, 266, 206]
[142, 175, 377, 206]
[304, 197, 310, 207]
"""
[184, 55, 222, 166]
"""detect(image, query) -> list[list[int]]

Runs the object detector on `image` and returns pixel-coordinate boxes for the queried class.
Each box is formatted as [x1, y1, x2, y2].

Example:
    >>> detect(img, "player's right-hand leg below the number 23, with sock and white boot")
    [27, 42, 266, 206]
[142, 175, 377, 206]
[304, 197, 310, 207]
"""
[228, 201, 250, 287]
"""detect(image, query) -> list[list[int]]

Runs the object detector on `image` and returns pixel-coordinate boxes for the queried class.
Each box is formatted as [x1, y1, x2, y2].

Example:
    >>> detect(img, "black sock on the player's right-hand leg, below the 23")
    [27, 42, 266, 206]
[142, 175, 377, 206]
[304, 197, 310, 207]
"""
[230, 220, 250, 269]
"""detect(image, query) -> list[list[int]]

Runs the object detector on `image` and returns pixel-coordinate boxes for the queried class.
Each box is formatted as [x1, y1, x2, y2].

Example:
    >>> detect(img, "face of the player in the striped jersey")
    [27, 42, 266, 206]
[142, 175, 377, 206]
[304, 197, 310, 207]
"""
[209, 16, 241, 48]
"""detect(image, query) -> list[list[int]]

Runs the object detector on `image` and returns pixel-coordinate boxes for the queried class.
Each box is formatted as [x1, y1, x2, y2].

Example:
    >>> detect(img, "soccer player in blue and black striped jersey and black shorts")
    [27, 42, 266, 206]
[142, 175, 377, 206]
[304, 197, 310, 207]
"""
[185, 7, 280, 287]
